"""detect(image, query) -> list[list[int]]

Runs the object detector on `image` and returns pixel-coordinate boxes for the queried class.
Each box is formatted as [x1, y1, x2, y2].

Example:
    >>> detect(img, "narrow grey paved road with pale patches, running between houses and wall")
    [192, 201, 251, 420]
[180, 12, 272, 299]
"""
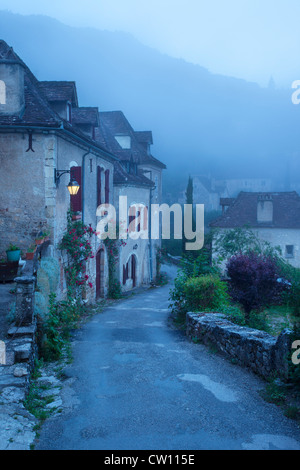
[36, 266, 300, 450]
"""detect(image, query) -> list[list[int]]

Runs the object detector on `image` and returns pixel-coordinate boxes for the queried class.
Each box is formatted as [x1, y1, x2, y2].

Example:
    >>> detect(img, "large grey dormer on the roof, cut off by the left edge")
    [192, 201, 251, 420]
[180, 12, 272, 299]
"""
[0, 41, 25, 116]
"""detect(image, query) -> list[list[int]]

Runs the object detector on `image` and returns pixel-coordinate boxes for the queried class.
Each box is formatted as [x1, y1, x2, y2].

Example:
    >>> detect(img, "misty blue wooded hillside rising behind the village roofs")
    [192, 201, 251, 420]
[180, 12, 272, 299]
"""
[0, 12, 300, 193]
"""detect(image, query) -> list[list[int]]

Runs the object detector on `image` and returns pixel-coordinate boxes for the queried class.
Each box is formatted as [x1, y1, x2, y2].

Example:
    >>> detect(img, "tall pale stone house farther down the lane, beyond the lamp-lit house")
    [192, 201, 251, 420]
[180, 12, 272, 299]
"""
[96, 111, 166, 291]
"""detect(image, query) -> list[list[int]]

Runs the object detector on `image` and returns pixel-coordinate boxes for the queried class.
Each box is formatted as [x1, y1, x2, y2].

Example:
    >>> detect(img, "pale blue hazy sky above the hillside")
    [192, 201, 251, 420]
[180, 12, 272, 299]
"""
[0, 0, 300, 87]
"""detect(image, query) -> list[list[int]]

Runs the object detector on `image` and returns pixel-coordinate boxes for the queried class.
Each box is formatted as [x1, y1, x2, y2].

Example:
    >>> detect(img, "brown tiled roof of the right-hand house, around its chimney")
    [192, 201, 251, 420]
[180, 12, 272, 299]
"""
[210, 191, 300, 229]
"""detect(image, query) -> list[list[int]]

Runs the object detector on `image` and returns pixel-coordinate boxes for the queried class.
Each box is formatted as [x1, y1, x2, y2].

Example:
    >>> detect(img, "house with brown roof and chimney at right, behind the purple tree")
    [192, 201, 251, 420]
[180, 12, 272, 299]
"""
[210, 191, 300, 268]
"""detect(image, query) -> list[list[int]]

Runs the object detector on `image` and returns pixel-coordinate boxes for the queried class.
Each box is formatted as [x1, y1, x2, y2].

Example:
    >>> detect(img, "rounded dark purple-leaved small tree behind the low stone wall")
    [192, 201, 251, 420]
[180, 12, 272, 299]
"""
[226, 252, 284, 322]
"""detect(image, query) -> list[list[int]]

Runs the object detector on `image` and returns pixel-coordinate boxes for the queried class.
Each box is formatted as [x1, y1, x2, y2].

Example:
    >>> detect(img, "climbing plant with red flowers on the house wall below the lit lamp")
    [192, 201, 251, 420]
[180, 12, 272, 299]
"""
[58, 211, 96, 297]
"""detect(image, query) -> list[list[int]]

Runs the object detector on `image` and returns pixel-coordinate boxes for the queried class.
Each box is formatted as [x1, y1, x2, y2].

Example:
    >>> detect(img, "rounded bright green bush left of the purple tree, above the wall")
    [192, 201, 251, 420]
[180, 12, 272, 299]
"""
[184, 275, 228, 311]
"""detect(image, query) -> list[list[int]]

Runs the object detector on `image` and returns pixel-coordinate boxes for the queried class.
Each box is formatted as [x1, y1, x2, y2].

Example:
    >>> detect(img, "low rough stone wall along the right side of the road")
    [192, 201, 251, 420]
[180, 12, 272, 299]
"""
[186, 312, 292, 380]
